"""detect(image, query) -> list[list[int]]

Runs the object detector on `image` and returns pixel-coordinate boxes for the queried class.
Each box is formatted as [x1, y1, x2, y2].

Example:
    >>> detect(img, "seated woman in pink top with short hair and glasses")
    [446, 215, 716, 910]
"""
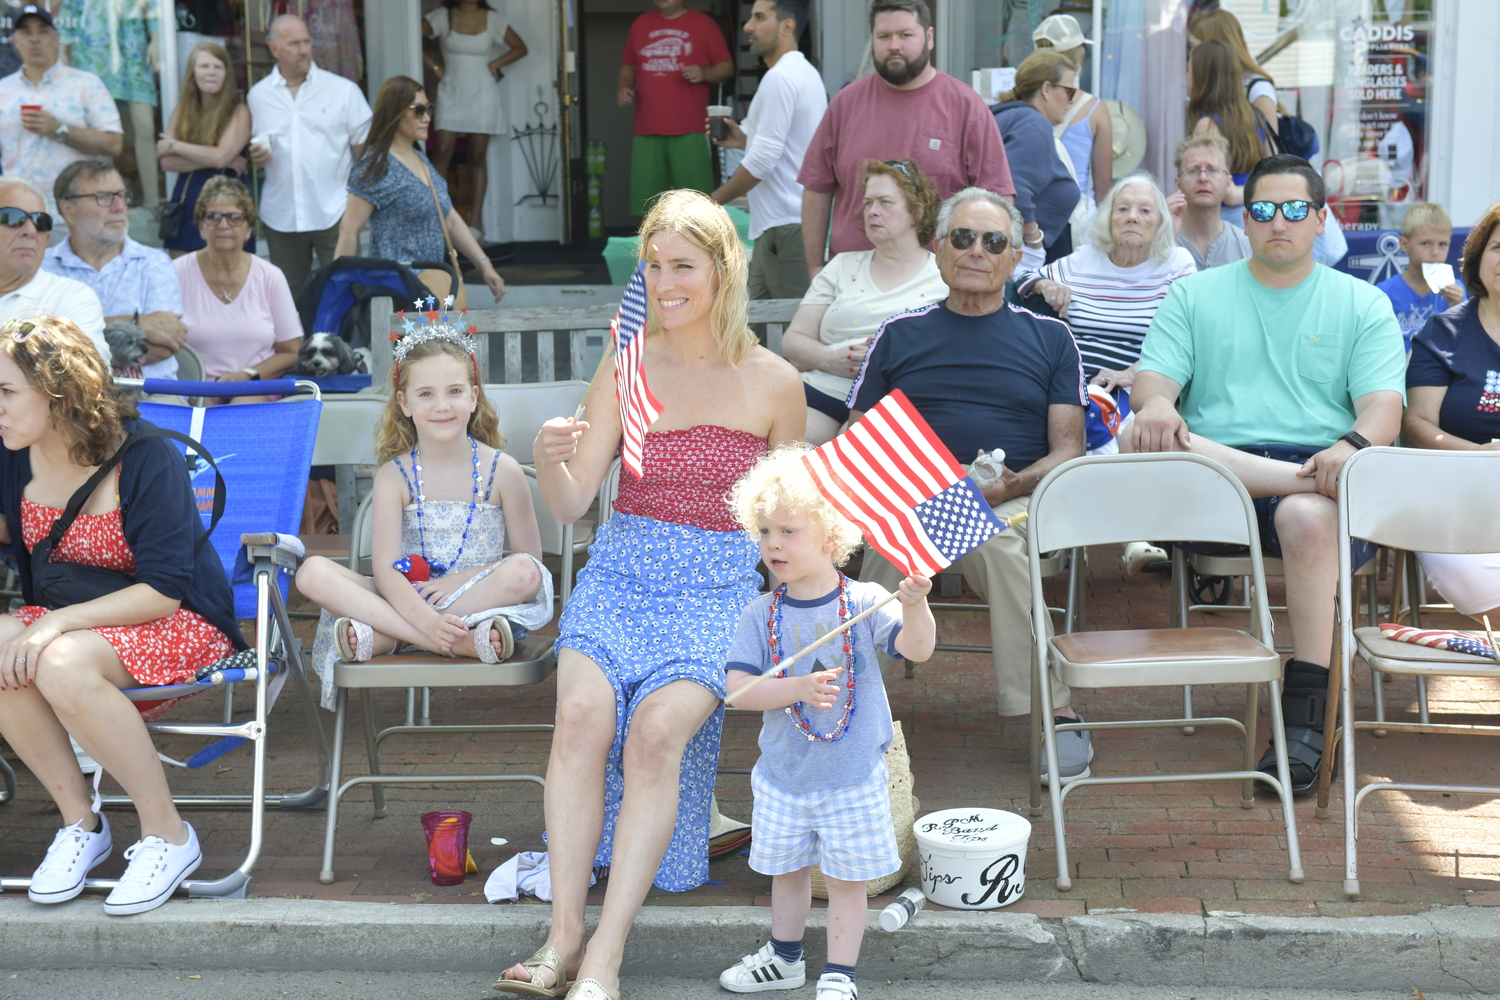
[173, 177, 302, 403]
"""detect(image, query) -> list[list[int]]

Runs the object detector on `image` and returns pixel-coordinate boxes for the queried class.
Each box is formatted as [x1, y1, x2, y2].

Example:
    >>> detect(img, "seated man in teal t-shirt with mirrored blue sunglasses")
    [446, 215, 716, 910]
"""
[1121, 156, 1406, 792]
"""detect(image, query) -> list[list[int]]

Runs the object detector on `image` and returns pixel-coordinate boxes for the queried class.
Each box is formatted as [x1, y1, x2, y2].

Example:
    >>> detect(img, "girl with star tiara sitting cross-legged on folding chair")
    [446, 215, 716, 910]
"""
[297, 320, 552, 697]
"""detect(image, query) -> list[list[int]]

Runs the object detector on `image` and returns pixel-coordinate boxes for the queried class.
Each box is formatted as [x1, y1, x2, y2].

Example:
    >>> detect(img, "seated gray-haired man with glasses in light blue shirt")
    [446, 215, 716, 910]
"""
[42, 160, 188, 378]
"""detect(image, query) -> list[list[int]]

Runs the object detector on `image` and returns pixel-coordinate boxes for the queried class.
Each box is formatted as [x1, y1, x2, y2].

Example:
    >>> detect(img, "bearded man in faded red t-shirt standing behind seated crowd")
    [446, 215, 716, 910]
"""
[797, 0, 1016, 276]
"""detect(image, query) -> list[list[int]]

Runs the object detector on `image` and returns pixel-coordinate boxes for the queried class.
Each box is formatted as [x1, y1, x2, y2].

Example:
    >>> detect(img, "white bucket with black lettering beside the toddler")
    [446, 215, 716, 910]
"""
[914, 808, 1031, 910]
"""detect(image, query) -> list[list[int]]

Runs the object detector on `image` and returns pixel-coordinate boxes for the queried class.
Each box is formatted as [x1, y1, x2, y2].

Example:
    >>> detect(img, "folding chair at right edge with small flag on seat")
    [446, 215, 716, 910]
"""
[1317, 448, 1500, 897]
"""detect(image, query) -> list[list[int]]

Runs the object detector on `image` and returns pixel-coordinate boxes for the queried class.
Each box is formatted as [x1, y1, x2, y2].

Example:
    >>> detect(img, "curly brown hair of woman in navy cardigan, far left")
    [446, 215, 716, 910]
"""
[0, 316, 141, 468]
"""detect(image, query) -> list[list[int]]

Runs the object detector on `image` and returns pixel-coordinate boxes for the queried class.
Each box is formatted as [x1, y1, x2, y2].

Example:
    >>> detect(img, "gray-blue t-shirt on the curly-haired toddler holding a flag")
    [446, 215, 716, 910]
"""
[726, 580, 902, 792]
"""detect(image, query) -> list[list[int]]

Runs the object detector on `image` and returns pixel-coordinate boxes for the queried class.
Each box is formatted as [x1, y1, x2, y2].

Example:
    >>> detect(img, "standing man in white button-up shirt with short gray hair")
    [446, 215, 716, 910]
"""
[246, 13, 371, 295]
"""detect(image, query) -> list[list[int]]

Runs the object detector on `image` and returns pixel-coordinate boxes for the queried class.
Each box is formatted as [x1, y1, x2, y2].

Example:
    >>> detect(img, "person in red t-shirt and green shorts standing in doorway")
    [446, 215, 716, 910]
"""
[618, 0, 735, 216]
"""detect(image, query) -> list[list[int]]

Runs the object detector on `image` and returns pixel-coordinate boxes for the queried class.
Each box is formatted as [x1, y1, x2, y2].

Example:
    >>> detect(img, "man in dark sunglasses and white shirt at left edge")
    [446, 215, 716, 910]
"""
[0, 175, 110, 360]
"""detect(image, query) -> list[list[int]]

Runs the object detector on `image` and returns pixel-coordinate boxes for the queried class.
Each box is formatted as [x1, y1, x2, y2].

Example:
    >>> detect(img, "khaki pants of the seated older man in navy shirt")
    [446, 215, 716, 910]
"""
[860, 496, 1073, 715]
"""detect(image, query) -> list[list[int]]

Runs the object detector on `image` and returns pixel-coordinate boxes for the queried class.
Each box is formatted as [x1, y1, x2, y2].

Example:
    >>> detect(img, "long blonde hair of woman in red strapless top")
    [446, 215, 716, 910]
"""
[641, 190, 759, 364]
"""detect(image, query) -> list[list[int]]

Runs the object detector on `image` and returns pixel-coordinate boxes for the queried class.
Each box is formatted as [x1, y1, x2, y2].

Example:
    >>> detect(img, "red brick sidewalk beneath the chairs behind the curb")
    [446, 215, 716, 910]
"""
[0, 549, 1500, 916]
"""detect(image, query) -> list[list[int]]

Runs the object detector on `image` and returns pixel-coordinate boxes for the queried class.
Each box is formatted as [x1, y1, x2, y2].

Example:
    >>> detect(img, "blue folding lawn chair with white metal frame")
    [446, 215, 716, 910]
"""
[0, 379, 330, 898]
